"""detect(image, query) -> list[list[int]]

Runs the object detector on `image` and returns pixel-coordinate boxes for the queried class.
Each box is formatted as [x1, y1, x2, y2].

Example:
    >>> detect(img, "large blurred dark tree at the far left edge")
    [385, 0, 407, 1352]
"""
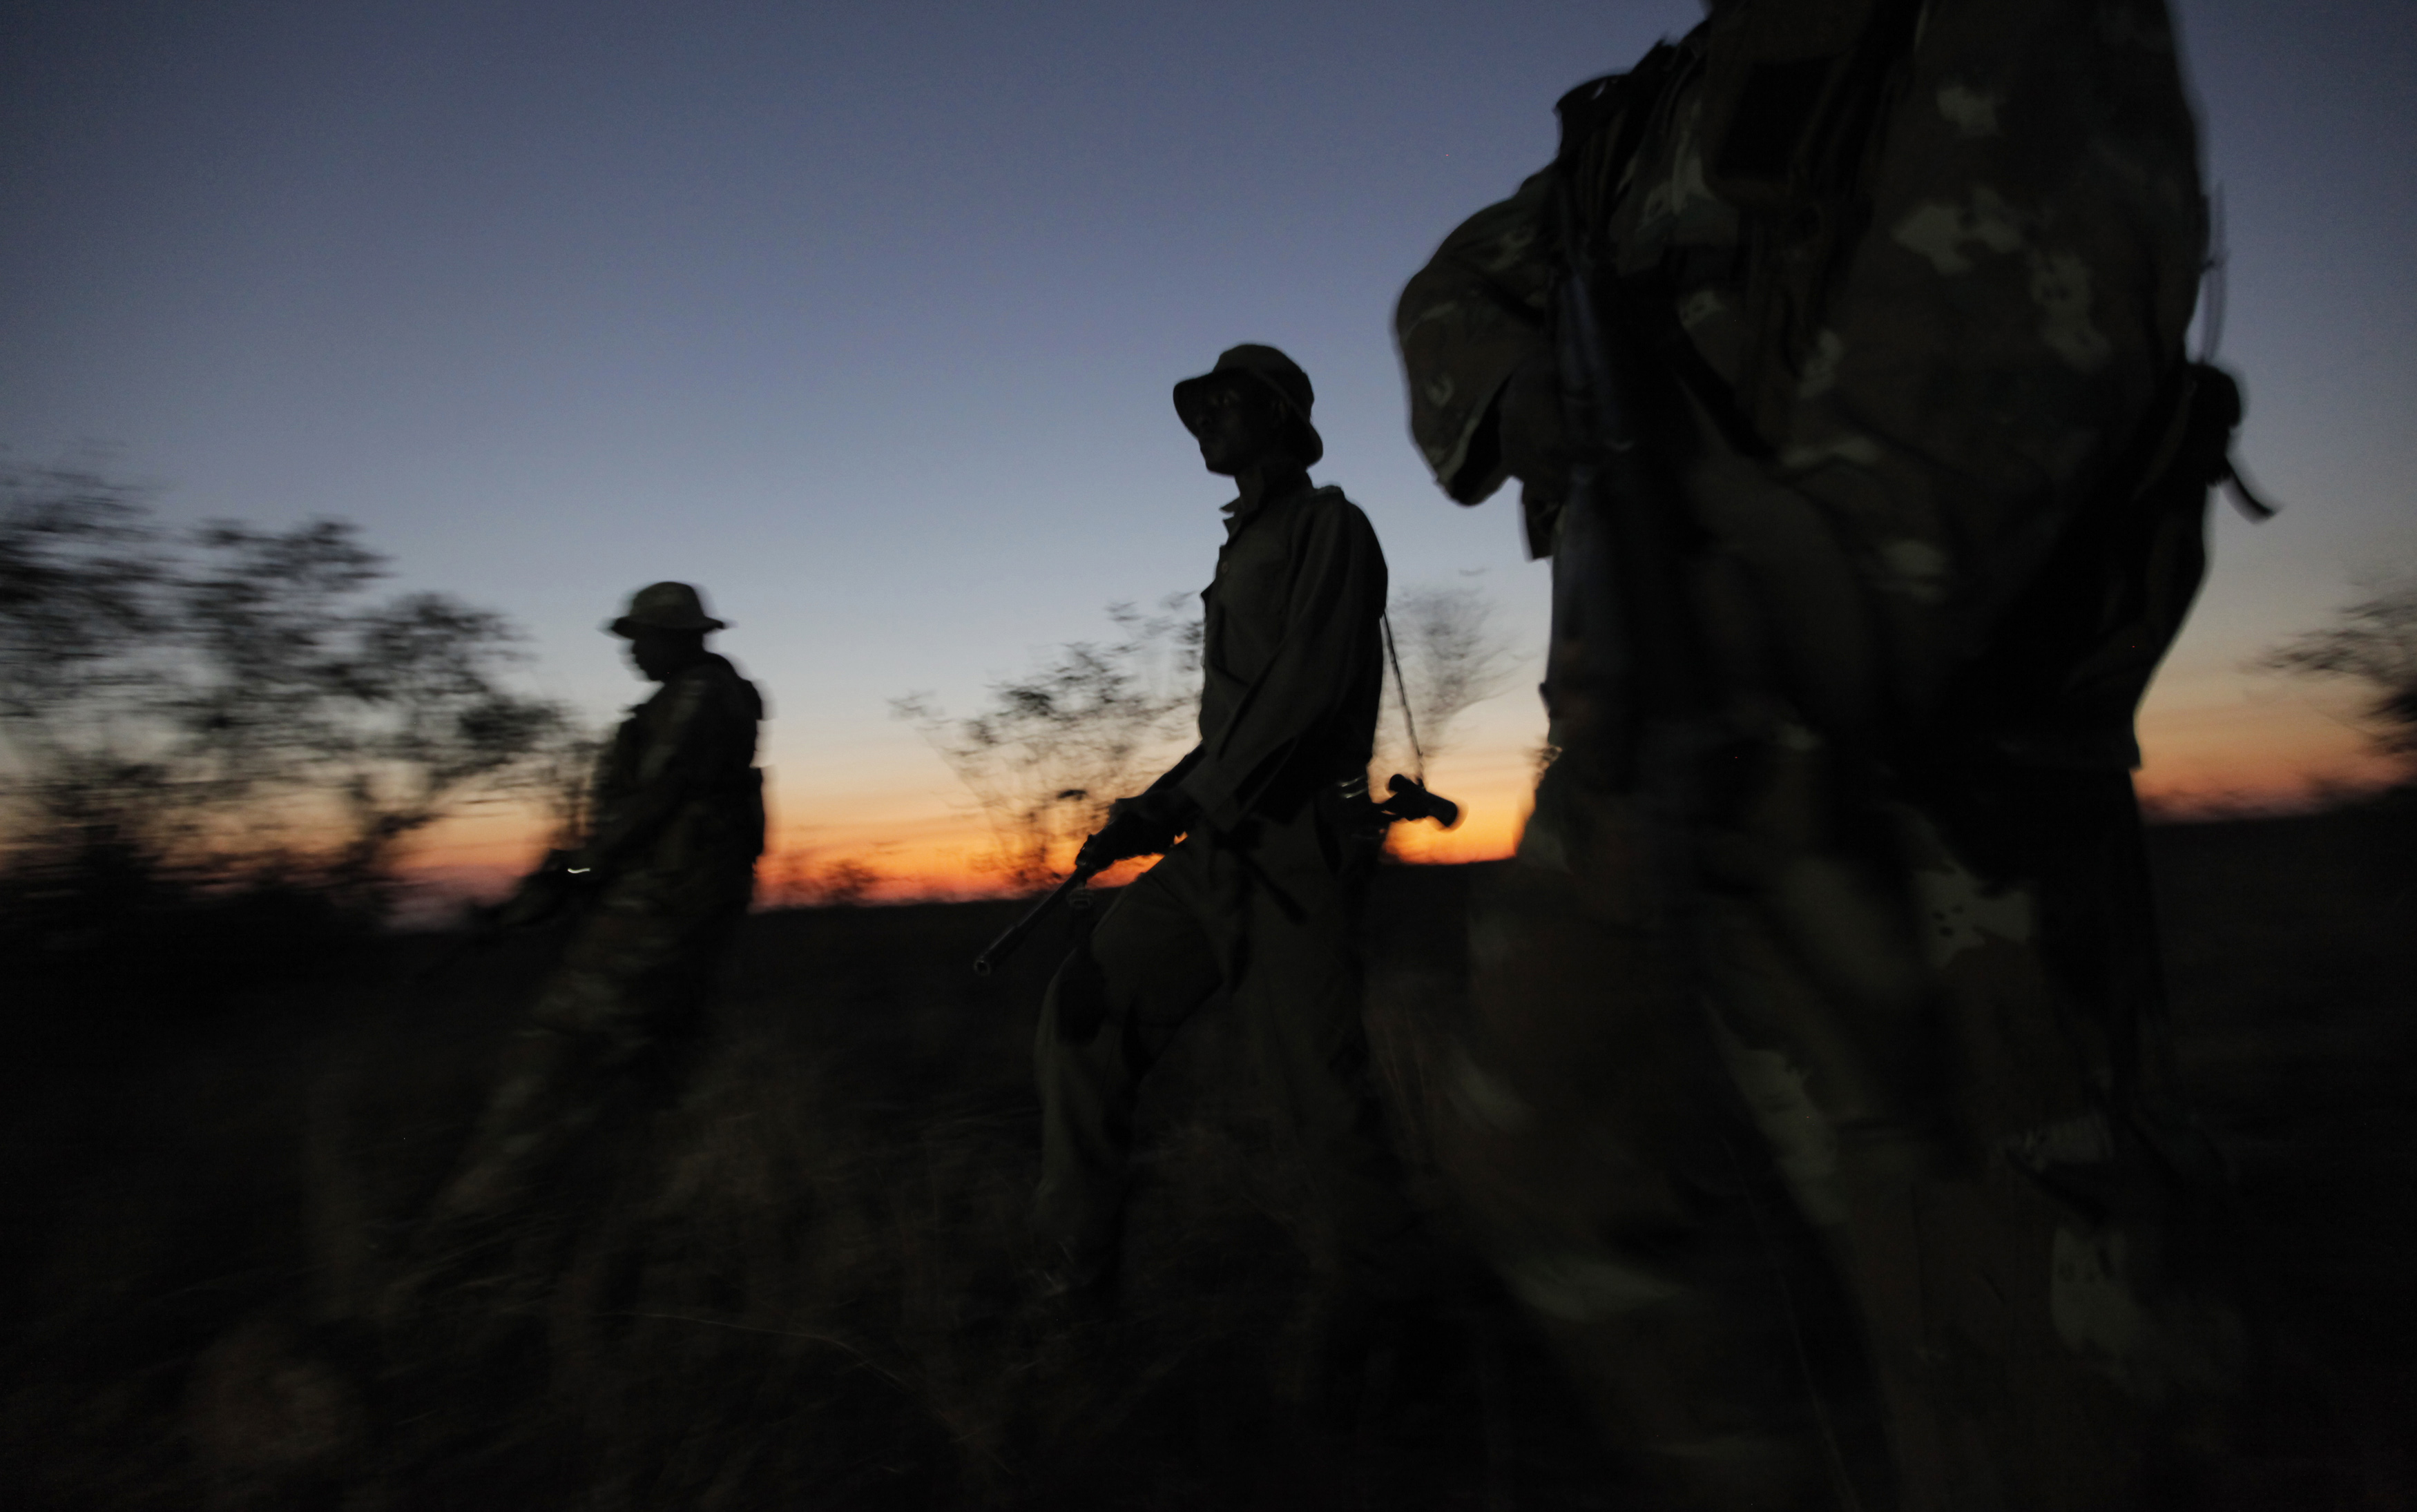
[0, 454, 573, 922]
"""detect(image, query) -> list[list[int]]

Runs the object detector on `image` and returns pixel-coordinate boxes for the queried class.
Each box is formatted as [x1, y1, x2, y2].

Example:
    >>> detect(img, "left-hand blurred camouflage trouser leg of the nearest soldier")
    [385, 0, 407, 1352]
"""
[1438, 777, 1885, 1510]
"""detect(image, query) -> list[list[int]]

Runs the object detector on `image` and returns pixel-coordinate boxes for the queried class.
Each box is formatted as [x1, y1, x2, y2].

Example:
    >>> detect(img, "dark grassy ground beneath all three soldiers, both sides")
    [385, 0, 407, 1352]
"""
[0, 809, 2417, 1512]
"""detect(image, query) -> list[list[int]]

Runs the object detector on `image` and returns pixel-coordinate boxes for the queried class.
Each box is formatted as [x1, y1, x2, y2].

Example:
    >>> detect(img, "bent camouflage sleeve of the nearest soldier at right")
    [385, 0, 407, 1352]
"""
[1392, 169, 1554, 505]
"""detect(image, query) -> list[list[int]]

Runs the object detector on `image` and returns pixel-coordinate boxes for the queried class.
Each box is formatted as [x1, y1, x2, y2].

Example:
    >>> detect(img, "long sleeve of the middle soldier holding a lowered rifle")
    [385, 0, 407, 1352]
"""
[1179, 498, 1385, 828]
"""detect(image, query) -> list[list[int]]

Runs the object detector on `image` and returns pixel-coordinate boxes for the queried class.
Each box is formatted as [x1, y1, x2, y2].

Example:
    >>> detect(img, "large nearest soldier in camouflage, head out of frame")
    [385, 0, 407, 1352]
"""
[1397, 0, 2238, 1512]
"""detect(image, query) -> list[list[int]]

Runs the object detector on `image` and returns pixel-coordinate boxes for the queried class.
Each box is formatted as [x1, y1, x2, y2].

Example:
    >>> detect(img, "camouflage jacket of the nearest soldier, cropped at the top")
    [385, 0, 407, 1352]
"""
[1395, 0, 2204, 720]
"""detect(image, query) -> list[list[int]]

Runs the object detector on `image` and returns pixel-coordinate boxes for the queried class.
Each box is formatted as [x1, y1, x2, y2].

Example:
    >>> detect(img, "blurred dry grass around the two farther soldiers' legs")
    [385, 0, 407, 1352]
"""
[0, 874, 1600, 1510]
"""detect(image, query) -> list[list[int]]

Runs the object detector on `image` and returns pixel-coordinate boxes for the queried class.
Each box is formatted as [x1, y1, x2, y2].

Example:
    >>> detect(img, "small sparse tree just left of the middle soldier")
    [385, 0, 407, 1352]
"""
[889, 594, 1202, 886]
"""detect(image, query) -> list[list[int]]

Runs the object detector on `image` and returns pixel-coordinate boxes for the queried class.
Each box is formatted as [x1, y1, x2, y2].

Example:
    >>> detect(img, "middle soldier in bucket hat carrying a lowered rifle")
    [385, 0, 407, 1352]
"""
[1032, 345, 1416, 1299]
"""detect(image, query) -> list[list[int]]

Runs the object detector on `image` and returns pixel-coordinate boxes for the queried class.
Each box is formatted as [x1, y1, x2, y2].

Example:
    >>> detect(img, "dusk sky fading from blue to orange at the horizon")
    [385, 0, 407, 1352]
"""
[0, 0, 2417, 879]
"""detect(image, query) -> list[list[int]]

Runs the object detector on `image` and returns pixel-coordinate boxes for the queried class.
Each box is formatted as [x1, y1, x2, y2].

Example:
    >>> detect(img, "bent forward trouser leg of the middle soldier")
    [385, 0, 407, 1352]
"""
[1032, 840, 1221, 1270]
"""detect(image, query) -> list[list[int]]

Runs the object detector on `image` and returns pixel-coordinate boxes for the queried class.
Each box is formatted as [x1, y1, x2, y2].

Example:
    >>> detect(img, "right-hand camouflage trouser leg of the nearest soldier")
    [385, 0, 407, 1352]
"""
[1706, 768, 2231, 1512]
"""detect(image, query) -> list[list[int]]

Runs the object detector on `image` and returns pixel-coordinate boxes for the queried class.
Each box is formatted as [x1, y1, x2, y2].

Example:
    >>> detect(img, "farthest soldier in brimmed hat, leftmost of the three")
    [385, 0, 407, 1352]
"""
[423, 582, 764, 1246]
